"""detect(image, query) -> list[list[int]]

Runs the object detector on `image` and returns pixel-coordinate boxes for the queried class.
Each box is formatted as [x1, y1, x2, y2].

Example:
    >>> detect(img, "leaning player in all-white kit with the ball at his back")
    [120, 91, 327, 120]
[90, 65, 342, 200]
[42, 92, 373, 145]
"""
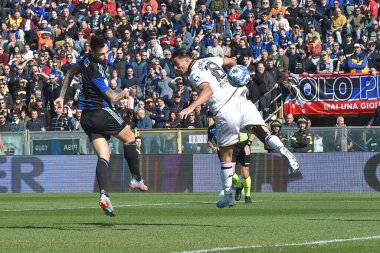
[172, 49, 299, 208]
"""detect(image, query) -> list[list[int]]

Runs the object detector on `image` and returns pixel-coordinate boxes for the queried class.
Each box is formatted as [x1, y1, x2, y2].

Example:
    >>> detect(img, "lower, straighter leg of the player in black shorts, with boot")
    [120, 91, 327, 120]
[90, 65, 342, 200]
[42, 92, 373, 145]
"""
[91, 137, 115, 216]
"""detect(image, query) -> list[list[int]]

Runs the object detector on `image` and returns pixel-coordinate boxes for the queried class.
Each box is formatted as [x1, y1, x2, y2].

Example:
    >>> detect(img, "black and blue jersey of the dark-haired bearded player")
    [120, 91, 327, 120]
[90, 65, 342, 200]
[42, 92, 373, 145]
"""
[77, 54, 112, 110]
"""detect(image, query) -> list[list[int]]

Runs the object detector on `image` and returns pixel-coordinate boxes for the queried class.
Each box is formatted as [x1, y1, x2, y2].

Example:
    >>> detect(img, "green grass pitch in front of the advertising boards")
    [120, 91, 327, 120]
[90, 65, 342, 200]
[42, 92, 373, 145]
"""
[0, 193, 380, 253]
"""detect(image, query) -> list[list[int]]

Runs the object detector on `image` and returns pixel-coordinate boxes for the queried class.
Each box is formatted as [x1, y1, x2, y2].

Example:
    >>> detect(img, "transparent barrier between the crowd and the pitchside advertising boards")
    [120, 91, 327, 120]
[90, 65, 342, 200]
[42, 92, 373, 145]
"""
[1, 127, 380, 155]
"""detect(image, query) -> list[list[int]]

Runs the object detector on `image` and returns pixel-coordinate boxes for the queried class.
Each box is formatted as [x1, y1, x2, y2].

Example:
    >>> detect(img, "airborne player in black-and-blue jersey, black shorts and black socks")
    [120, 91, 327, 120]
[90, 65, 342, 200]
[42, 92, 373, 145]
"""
[55, 36, 148, 216]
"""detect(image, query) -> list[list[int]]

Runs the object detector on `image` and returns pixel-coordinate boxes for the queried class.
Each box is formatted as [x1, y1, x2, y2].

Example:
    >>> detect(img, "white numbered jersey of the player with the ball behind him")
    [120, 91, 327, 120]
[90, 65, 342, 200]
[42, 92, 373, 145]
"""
[189, 57, 248, 112]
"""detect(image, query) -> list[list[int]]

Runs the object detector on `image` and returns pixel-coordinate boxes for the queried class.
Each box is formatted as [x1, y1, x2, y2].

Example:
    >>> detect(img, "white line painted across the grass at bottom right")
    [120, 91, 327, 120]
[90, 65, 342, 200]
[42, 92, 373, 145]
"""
[175, 235, 380, 253]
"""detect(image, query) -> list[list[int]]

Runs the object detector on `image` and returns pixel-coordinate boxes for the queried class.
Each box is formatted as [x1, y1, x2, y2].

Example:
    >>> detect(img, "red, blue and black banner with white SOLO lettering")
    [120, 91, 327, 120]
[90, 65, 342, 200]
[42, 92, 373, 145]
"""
[284, 73, 380, 116]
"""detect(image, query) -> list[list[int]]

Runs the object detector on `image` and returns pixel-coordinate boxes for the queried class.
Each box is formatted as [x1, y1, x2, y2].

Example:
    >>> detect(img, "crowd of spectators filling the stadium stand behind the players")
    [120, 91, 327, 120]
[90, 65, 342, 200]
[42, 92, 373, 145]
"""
[0, 0, 380, 132]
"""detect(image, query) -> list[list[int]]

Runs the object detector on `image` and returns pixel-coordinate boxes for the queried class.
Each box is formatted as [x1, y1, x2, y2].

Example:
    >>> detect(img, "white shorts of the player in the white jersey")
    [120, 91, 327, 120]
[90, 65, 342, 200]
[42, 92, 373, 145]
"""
[215, 95, 265, 147]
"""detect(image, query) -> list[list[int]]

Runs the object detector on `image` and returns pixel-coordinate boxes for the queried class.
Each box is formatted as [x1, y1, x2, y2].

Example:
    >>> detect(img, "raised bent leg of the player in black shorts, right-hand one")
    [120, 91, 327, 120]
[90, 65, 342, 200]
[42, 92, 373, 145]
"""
[114, 126, 148, 192]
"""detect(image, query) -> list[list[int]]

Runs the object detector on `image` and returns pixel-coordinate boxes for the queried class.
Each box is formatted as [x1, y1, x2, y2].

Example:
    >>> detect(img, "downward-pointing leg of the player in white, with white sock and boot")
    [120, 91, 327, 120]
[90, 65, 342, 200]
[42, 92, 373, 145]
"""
[216, 146, 236, 208]
